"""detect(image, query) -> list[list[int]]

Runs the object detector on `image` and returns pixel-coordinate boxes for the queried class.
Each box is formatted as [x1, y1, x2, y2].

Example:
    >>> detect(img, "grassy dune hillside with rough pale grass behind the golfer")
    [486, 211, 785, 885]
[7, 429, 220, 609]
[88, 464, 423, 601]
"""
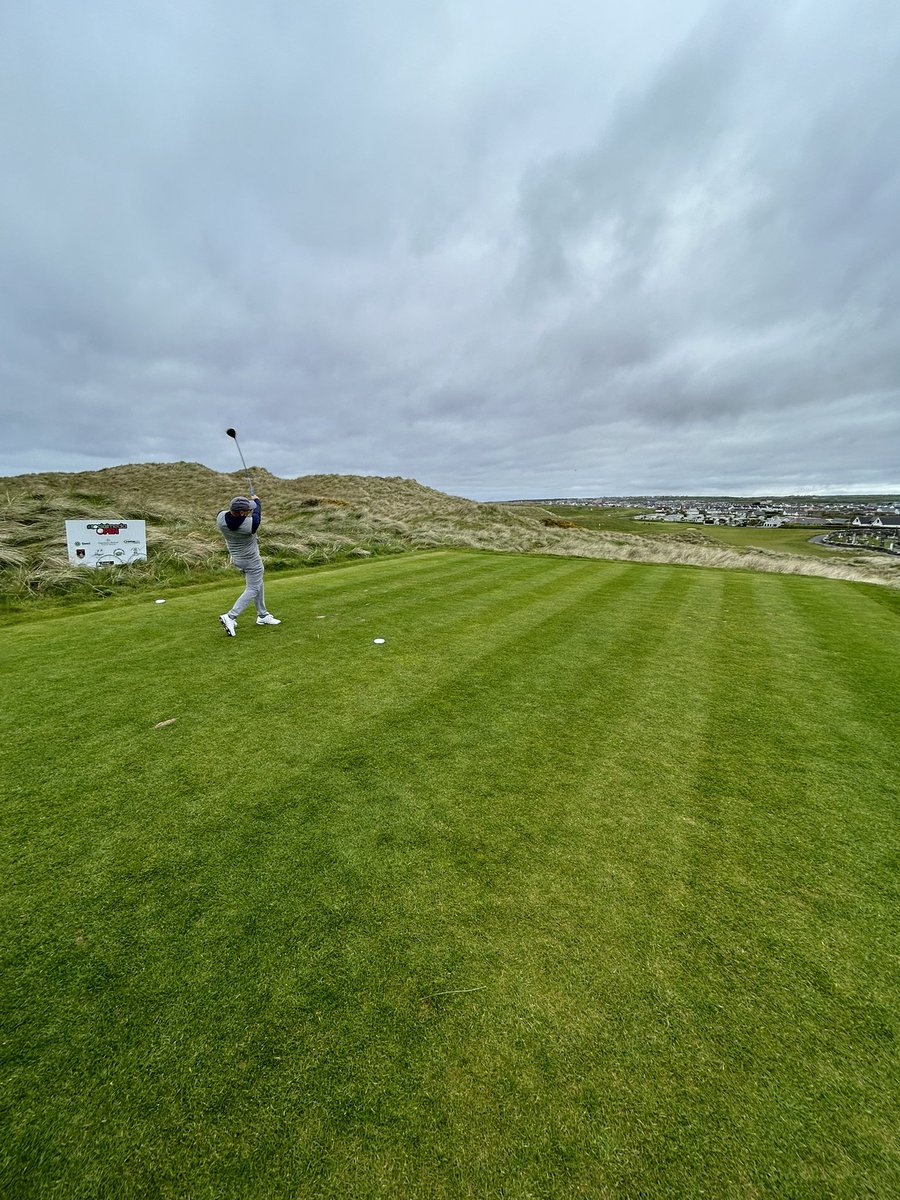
[0, 462, 900, 607]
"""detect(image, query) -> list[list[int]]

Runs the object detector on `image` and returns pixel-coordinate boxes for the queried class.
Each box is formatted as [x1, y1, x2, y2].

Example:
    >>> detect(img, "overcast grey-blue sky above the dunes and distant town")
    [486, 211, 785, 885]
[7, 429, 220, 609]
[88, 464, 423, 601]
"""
[0, 0, 900, 499]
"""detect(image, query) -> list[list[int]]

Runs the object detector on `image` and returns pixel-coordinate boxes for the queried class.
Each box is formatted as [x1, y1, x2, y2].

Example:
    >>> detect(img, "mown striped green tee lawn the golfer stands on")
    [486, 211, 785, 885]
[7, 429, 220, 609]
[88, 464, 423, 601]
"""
[0, 551, 900, 1200]
